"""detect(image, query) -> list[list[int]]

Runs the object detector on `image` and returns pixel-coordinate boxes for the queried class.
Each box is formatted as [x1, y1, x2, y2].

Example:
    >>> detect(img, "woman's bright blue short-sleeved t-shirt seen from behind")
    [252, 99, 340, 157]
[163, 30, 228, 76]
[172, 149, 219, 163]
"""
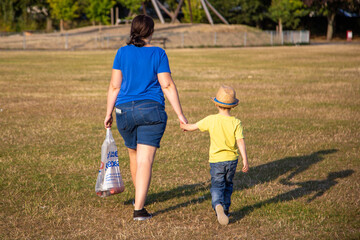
[113, 45, 170, 106]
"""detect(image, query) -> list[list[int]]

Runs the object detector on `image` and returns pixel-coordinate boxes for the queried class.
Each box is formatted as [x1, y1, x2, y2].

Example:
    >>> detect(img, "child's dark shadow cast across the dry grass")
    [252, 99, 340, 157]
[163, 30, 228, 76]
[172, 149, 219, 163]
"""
[231, 170, 354, 222]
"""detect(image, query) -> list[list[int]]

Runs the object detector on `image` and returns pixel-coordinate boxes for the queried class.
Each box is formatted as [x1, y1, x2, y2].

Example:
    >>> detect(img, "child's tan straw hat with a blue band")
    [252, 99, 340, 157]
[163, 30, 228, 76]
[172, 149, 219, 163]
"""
[211, 85, 239, 108]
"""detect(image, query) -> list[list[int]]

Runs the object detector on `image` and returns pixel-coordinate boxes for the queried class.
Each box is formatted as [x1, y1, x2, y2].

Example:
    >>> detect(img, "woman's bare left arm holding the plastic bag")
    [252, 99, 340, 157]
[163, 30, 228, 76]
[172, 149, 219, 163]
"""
[104, 69, 122, 128]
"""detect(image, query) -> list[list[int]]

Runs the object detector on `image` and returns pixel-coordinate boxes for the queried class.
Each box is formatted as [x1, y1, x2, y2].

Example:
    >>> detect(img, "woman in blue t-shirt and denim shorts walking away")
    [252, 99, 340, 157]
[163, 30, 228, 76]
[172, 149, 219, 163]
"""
[104, 15, 187, 220]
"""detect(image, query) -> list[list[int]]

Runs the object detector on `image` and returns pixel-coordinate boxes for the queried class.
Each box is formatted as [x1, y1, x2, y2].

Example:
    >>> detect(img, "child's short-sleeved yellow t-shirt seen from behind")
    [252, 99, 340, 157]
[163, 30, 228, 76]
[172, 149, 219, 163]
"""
[196, 114, 244, 163]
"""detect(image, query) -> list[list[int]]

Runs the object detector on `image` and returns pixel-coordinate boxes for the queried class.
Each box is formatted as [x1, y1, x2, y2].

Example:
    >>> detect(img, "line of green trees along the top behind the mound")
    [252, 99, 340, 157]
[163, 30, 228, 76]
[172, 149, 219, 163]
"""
[0, 0, 360, 39]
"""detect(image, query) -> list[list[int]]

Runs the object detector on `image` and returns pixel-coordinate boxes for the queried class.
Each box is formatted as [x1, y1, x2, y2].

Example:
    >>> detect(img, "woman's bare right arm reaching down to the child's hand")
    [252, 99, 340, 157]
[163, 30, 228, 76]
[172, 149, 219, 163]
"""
[158, 72, 187, 124]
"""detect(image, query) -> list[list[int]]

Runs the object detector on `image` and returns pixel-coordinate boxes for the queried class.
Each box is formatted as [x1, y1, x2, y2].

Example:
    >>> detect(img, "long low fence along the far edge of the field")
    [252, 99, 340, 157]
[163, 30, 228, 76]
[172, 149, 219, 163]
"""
[0, 31, 310, 50]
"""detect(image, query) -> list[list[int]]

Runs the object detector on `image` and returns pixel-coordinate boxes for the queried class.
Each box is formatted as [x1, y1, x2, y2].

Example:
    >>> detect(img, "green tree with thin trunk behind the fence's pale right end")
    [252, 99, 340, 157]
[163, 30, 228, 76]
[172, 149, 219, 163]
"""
[269, 0, 309, 35]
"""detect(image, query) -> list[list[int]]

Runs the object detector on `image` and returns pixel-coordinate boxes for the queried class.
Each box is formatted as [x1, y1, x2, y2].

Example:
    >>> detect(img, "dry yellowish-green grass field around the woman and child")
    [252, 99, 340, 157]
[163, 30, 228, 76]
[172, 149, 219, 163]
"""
[0, 45, 360, 239]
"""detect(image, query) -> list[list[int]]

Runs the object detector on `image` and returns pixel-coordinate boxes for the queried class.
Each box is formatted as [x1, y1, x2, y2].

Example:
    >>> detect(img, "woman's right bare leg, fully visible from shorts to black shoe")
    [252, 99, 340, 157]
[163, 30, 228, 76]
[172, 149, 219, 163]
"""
[135, 144, 156, 210]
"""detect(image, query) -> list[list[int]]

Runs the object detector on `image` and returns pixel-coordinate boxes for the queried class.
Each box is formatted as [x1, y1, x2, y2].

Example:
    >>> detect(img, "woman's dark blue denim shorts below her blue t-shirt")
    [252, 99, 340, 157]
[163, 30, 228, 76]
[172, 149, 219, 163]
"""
[116, 100, 167, 149]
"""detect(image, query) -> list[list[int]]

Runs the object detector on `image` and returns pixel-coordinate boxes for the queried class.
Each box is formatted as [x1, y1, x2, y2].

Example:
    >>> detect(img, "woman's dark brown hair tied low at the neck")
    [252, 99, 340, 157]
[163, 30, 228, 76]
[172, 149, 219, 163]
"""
[127, 15, 155, 47]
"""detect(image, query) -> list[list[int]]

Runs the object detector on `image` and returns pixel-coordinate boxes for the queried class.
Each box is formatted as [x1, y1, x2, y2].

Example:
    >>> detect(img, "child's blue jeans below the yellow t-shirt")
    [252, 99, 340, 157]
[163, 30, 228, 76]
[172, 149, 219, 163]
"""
[210, 160, 238, 211]
